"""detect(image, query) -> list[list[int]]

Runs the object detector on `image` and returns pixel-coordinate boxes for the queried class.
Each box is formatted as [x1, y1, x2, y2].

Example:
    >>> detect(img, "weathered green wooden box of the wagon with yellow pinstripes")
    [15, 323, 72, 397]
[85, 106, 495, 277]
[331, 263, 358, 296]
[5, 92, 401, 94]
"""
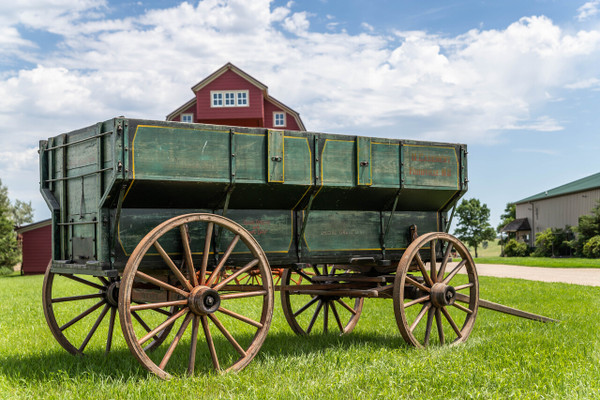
[40, 118, 467, 273]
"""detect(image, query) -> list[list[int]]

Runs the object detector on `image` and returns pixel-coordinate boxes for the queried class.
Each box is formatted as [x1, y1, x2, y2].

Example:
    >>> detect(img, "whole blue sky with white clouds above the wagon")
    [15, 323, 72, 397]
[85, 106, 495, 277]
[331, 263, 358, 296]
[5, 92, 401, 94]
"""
[0, 0, 600, 226]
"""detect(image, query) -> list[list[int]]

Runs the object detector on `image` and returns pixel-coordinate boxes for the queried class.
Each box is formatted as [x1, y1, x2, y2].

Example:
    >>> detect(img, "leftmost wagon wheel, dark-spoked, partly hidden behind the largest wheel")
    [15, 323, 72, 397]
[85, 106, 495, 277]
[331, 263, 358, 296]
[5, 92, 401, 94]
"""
[42, 263, 174, 355]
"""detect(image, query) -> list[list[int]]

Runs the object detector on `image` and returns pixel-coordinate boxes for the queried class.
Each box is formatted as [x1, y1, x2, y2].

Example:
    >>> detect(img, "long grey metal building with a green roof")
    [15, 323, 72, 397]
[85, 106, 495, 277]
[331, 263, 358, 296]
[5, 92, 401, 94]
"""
[515, 172, 600, 246]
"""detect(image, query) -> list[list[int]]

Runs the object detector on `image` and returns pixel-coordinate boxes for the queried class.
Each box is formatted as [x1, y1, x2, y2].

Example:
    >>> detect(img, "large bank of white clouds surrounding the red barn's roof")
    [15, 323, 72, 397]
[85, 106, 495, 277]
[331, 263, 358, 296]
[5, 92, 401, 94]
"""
[0, 0, 600, 219]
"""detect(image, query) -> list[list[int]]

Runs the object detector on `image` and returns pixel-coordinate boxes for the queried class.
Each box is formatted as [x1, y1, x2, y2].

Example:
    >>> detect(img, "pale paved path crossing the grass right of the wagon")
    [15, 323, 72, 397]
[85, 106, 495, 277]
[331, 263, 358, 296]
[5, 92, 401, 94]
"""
[477, 264, 600, 286]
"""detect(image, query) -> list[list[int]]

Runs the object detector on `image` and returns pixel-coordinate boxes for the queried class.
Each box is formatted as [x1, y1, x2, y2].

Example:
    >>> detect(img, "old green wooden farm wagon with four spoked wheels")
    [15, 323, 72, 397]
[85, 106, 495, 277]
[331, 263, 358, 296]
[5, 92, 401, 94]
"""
[40, 118, 548, 378]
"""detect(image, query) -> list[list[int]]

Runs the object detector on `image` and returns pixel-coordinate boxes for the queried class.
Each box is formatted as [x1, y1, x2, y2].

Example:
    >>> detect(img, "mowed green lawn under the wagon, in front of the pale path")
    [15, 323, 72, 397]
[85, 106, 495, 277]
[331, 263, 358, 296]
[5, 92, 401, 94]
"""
[0, 276, 600, 399]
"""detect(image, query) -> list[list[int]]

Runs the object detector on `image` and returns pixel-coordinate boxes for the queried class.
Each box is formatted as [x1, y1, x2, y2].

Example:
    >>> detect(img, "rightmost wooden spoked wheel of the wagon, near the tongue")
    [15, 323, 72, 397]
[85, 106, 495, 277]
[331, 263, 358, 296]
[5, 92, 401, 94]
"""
[393, 232, 479, 347]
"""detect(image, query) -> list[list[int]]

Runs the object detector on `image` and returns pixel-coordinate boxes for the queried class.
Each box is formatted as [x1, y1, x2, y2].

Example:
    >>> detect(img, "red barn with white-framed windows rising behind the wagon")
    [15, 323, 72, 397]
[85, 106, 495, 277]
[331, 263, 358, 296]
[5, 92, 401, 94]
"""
[167, 63, 306, 131]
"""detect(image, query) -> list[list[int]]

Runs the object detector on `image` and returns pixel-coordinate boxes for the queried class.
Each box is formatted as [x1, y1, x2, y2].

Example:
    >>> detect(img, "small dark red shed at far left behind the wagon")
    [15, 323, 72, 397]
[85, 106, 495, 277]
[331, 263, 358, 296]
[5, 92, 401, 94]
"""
[17, 219, 52, 275]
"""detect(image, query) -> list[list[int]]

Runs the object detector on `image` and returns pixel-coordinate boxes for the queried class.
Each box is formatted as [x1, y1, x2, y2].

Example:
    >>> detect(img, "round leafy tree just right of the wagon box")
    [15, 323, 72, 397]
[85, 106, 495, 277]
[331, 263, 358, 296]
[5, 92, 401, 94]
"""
[454, 199, 496, 257]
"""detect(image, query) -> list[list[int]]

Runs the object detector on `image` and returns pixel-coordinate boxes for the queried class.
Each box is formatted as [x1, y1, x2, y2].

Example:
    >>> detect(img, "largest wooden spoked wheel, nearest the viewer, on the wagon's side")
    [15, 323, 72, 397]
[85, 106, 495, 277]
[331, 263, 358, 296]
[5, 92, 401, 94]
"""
[119, 213, 273, 379]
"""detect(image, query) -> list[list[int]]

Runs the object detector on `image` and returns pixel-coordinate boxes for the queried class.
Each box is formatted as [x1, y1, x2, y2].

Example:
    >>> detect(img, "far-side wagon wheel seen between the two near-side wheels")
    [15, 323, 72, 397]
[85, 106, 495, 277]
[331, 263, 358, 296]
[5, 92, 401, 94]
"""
[281, 264, 364, 335]
